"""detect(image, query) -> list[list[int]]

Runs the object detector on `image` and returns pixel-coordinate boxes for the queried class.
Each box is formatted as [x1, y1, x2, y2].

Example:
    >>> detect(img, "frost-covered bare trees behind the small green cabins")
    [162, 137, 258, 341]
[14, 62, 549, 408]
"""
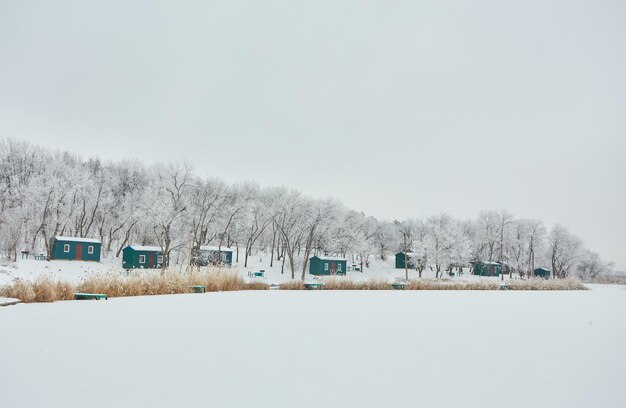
[0, 139, 612, 279]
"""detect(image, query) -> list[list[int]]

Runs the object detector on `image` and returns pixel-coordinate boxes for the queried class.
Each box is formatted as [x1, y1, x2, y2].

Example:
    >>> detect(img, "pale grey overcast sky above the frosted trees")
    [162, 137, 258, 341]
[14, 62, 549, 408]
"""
[0, 0, 626, 269]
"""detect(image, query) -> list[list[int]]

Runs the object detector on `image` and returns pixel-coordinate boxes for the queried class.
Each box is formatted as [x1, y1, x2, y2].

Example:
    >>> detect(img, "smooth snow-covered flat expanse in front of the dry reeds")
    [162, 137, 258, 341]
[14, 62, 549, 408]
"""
[0, 286, 626, 408]
